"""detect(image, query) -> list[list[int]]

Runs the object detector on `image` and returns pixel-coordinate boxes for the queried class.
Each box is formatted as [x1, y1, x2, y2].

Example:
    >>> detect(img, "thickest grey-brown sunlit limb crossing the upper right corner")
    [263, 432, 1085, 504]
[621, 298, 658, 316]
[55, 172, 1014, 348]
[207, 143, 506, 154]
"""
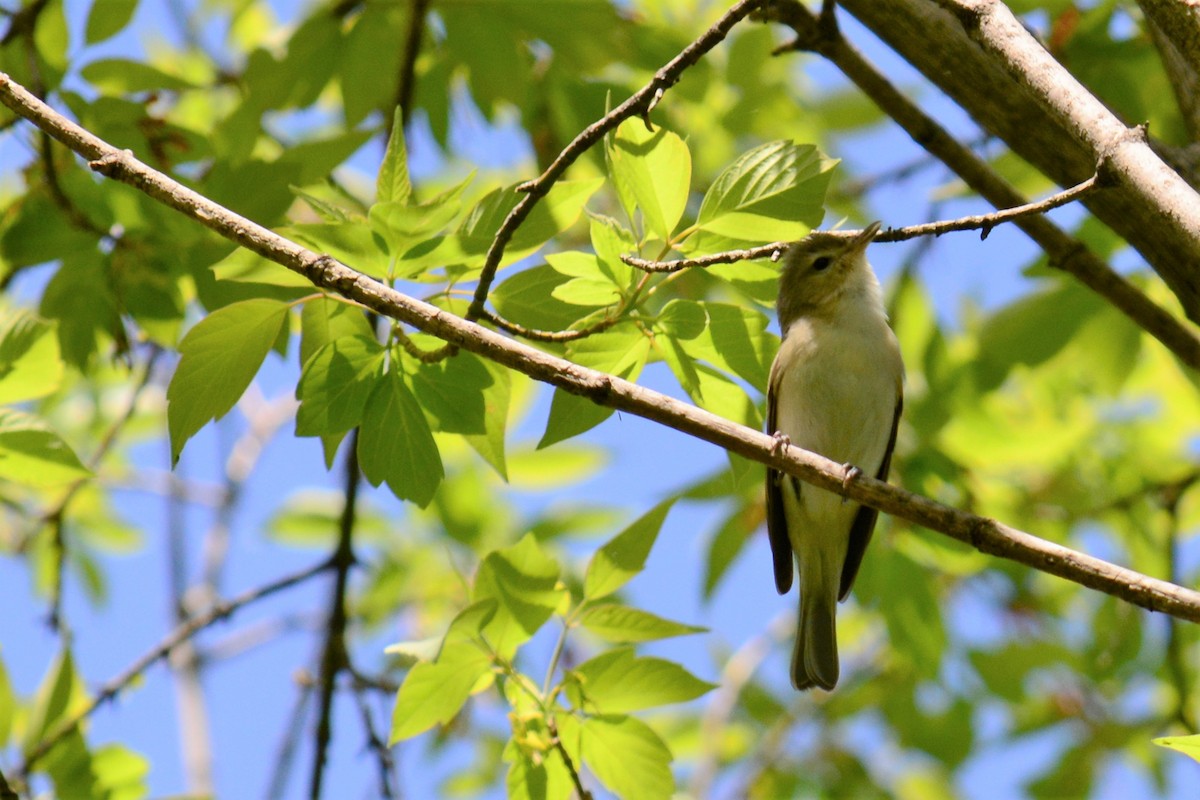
[840, 0, 1200, 321]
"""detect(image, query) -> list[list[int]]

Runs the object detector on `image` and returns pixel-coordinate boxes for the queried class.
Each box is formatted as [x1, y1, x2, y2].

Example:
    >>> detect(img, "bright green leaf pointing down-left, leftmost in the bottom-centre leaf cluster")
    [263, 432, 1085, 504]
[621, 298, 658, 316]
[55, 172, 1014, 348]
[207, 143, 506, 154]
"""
[388, 642, 492, 745]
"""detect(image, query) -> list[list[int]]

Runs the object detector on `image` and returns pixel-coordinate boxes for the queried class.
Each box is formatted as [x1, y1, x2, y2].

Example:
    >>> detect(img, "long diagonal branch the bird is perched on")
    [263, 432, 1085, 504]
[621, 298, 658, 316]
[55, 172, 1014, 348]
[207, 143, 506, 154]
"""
[0, 73, 1200, 628]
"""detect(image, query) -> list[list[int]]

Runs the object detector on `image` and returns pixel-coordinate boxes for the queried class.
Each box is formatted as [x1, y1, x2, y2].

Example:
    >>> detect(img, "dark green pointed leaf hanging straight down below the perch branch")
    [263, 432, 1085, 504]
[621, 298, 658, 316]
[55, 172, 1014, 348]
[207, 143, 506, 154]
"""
[359, 371, 445, 509]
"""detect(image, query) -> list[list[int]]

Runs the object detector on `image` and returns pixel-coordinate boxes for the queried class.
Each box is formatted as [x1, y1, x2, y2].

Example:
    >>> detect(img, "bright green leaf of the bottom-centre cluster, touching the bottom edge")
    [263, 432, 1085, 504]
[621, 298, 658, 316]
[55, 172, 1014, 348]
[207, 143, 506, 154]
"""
[580, 716, 674, 800]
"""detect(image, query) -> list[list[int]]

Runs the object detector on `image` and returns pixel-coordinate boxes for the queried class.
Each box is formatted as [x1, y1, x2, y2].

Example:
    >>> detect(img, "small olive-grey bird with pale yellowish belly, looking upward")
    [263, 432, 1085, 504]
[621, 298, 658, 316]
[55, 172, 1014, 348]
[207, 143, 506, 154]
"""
[767, 222, 904, 691]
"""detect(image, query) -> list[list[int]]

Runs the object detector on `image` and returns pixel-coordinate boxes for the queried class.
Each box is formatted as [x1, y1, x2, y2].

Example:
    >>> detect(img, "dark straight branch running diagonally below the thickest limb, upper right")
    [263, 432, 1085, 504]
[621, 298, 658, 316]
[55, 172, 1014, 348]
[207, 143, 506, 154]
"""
[775, 0, 1200, 369]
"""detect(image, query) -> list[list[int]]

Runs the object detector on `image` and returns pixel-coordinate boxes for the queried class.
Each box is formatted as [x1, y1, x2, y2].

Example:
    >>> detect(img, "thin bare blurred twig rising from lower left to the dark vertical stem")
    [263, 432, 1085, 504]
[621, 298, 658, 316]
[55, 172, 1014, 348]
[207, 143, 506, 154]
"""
[17, 560, 334, 777]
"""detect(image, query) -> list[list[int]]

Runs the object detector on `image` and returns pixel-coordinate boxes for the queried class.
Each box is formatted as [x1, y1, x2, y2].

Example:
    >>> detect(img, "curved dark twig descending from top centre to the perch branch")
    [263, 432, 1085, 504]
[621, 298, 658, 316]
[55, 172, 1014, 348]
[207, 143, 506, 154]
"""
[467, 0, 766, 320]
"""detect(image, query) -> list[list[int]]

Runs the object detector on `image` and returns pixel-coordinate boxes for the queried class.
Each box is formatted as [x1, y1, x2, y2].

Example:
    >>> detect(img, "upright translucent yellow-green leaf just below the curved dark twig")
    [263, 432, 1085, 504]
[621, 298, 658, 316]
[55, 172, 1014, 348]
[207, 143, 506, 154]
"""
[607, 119, 691, 241]
